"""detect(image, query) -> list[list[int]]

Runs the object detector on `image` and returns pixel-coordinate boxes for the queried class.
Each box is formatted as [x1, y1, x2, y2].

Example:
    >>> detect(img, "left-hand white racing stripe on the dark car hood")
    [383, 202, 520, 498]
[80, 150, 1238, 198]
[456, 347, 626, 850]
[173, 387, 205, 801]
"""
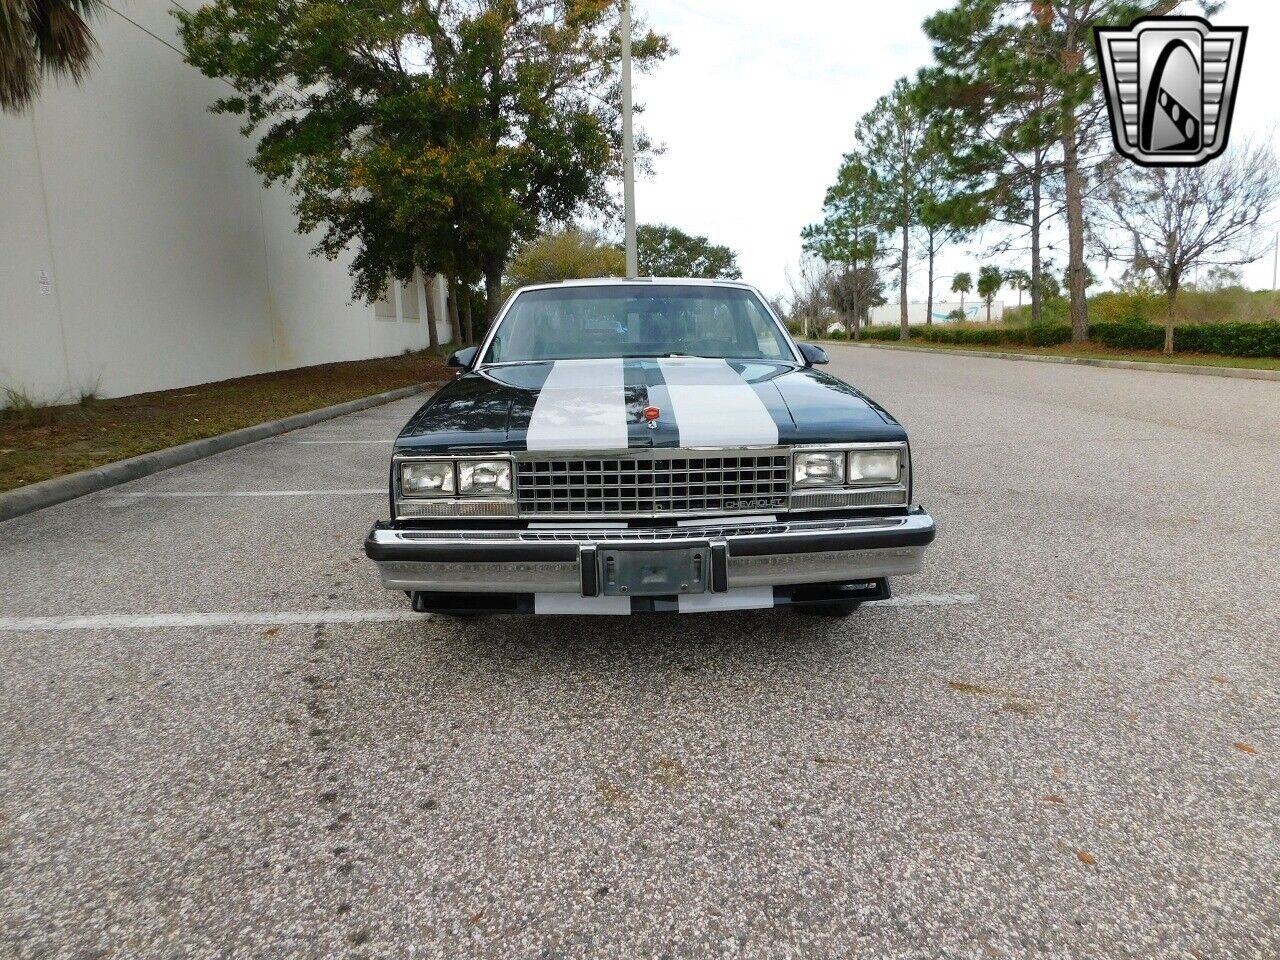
[525, 360, 627, 451]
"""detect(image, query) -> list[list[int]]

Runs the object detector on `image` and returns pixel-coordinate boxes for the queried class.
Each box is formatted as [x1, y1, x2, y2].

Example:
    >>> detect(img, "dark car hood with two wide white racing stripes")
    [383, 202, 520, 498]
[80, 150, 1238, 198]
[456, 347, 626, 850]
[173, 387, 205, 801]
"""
[396, 357, 906, 452]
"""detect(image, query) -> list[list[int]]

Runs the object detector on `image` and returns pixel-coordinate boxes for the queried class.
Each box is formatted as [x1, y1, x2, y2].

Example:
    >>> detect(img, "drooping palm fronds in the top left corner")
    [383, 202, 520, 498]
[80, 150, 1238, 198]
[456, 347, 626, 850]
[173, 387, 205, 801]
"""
[0, 0, 102, 113]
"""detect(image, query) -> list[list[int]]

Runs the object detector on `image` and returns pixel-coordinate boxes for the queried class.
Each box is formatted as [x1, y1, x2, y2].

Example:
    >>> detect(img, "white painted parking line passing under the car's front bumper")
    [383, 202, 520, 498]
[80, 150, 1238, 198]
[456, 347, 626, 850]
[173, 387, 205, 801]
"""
[0, 594, 978, 634]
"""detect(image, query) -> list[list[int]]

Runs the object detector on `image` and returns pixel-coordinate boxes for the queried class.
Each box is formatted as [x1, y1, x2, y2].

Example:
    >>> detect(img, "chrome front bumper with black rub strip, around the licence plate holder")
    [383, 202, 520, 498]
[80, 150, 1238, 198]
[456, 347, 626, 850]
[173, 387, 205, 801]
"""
[365, 507, 936, 596]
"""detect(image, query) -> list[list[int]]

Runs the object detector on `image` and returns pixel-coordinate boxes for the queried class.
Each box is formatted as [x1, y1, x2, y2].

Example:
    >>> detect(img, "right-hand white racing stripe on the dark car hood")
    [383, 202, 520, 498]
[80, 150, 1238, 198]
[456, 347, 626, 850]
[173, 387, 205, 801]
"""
[658, 357, 778, 447]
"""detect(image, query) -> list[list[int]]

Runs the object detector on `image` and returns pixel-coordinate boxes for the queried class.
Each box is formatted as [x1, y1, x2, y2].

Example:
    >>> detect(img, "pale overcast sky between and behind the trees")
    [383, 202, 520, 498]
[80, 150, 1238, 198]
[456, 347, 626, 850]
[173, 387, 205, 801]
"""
[632, 0, 1280, 300]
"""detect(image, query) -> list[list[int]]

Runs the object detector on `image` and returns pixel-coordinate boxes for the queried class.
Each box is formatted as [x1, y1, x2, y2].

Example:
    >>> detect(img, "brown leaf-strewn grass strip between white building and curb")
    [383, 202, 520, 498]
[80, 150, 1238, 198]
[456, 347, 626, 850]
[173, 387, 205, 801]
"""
[0, 351, 448, 490]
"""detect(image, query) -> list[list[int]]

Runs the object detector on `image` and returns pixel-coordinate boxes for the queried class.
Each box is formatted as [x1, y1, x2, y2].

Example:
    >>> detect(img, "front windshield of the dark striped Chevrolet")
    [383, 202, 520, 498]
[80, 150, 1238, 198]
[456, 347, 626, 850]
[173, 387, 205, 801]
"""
[483, 284, 795, 364]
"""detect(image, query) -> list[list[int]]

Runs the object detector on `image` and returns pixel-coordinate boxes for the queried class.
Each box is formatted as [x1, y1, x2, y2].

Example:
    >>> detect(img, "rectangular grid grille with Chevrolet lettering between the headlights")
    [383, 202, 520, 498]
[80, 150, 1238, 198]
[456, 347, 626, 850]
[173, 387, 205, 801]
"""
[516, 449, 791, 517]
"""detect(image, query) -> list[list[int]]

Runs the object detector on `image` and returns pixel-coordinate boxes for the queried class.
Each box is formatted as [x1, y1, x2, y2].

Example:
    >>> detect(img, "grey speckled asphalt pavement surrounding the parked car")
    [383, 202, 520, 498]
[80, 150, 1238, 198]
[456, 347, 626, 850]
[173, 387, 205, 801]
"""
[0, 347, 1280, 960]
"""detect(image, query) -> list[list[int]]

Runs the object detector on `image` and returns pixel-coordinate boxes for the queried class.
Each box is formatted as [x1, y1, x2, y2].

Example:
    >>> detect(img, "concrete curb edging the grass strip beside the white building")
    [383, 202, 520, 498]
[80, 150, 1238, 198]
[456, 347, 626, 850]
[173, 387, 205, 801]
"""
[0, 383, 439, 521]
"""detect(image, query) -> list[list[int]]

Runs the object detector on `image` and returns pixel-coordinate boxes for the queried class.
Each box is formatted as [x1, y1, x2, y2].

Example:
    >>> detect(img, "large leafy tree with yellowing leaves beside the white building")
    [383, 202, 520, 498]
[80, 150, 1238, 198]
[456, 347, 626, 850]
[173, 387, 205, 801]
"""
[175, 0, 668, 339]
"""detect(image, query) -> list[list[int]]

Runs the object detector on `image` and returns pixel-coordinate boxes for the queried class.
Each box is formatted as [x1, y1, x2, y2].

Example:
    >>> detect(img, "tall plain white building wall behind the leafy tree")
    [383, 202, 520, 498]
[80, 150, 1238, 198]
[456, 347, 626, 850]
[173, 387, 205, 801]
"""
[0, 0, 448, 401]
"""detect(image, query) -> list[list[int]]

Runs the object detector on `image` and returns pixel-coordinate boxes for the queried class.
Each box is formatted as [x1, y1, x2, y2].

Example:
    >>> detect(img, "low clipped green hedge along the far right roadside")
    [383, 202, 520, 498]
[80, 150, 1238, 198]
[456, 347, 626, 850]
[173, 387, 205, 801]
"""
[841, 320, 1280, 357]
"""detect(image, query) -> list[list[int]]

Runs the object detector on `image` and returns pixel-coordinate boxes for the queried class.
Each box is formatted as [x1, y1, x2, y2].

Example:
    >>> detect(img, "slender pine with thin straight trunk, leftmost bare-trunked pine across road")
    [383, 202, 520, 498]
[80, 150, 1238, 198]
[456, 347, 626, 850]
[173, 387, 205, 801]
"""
[855, 78, 928, 340]
